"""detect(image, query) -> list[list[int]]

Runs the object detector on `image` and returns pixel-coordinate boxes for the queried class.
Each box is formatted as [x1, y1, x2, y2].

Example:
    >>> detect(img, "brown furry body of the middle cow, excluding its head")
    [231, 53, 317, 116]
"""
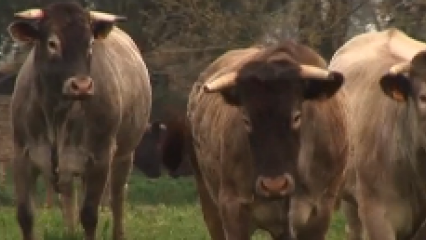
[162, 42, 347, 240]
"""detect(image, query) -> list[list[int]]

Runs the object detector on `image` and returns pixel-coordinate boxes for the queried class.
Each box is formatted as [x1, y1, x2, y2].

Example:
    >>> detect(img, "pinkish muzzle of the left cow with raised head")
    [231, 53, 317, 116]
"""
[62, 76, 95, 98]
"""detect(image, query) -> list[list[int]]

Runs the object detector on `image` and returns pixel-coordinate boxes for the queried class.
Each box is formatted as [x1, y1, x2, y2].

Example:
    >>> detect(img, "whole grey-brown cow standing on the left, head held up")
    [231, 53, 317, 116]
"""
[8, 2, 152, 240]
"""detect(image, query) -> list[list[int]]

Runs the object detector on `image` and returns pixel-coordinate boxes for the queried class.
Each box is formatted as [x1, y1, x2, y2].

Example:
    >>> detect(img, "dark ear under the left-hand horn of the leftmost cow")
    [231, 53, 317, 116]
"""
[7, 21, 39, 43]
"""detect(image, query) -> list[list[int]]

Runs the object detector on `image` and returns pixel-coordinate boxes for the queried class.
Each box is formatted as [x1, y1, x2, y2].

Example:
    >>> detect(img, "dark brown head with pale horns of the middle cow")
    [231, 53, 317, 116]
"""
[204, 47, 344, 197]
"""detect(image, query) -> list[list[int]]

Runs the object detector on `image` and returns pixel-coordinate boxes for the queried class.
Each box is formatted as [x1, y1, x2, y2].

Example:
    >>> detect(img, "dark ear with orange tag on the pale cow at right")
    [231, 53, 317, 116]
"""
[380, 74, 411, 102]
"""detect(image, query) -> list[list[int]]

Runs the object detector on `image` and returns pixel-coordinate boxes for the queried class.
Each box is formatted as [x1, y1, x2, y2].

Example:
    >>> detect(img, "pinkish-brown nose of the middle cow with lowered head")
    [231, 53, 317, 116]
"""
[256, 174, 294, 197]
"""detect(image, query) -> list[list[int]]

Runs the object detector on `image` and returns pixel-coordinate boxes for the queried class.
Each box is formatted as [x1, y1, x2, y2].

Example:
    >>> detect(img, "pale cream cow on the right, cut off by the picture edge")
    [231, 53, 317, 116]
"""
[330, 29, 426, 240]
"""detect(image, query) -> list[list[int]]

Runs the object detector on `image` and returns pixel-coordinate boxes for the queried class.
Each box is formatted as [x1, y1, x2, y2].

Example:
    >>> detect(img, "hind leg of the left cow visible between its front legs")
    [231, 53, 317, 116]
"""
[61, 181, 77, 233]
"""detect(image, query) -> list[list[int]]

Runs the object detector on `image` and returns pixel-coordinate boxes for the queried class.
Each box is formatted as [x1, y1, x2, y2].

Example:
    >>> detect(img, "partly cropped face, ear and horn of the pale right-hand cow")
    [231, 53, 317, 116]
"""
[380, 51, 426, 118]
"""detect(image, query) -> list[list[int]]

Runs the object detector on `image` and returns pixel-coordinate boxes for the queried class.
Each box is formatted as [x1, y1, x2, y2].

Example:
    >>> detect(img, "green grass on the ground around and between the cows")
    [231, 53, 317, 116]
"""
[0, 173, 344, 240]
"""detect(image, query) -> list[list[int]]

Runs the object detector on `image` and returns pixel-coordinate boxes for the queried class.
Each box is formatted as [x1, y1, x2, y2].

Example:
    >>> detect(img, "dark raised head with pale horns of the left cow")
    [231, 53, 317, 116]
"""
[8, 2, 124, 99]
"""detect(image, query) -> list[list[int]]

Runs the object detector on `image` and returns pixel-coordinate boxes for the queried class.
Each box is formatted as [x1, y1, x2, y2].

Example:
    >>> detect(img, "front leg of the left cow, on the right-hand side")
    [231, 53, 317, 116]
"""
[80, 164, 109, 240]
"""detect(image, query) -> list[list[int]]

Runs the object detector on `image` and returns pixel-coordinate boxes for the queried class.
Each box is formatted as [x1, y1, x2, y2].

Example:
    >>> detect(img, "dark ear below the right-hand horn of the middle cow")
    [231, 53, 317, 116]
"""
[304, 72, 344, 100]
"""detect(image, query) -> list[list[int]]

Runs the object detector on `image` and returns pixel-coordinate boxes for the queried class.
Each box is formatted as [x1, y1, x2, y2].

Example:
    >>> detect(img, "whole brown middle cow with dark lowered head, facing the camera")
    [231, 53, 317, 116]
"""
[163, 40, 348, 240]
